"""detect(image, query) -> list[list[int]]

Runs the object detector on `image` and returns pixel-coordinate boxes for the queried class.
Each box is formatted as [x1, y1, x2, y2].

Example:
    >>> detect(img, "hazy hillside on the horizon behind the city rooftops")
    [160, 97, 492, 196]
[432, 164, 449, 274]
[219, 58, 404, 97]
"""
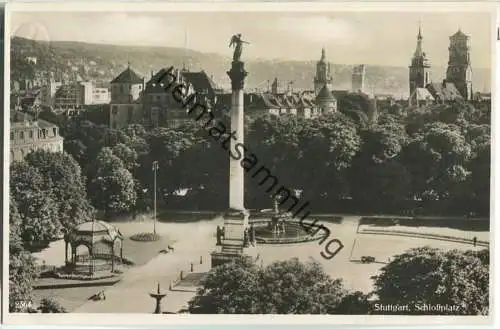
[11, 37, 491, 98]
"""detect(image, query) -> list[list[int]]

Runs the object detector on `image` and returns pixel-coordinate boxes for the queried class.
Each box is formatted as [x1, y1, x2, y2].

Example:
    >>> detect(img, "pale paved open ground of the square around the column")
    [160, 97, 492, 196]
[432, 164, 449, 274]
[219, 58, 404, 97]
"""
[36, 216, 487, 313]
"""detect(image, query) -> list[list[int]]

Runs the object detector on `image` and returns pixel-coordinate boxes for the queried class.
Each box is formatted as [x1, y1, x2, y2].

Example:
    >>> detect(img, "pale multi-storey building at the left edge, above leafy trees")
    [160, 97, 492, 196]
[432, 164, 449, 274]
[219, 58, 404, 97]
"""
[10, 111, 64, 162]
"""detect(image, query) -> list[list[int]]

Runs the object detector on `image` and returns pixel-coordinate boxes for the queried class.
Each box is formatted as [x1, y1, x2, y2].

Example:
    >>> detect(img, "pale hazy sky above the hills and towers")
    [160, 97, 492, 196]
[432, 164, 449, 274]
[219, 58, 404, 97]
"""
[11, 11, 491, 68]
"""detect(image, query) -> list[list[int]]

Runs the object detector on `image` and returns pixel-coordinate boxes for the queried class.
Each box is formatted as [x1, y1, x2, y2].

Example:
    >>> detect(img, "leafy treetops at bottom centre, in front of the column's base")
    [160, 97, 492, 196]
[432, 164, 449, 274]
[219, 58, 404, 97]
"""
[189, 259, 346, 314]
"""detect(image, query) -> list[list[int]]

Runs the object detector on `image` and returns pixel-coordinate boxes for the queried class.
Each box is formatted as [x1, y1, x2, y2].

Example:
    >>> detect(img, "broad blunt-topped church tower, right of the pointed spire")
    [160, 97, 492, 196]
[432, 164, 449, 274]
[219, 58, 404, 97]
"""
[446, 30, 472, 100]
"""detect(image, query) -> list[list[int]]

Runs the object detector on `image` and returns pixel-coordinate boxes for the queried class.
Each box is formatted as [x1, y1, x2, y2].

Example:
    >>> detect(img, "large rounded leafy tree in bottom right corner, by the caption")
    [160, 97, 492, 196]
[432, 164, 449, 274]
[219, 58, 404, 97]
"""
[374, 247, 489, 315]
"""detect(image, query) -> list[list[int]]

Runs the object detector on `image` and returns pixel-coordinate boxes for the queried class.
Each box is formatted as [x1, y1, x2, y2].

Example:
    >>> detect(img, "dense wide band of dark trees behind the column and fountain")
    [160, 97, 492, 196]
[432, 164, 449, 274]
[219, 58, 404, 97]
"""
[52, 95, 491, 216]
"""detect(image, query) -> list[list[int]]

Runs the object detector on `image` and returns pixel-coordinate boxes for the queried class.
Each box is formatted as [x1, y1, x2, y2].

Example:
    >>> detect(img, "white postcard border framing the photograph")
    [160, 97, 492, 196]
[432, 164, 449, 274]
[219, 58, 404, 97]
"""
[2, 1, 500, 326]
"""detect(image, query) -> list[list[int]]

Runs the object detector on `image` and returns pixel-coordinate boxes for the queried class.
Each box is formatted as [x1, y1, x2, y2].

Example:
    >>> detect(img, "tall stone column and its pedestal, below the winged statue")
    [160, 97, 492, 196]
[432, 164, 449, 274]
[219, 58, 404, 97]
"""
[212, 61, 249, 267]
